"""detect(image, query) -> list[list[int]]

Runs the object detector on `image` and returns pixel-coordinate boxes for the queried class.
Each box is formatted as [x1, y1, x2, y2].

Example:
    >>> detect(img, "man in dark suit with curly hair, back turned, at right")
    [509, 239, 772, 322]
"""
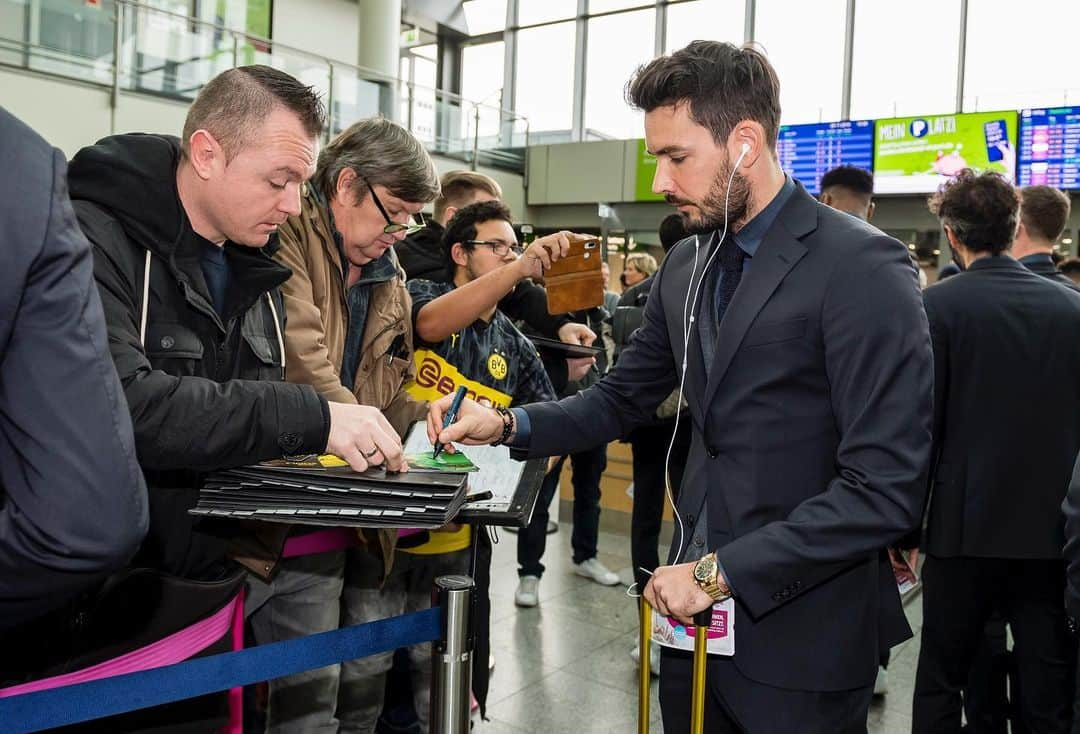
[914, 172, 1080, 733]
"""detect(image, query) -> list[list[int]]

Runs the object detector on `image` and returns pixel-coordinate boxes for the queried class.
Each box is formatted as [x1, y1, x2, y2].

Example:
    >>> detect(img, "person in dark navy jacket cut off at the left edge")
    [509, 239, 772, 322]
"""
[0, 108, 147, 660]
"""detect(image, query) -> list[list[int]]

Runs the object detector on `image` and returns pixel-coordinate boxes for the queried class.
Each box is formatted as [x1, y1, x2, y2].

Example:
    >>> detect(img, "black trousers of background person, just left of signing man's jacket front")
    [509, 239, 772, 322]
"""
[630, 416, 690, 589]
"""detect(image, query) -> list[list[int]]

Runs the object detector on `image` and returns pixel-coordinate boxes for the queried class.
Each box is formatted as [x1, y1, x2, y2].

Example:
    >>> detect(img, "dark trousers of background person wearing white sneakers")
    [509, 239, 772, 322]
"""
[517, 445, 607, 576]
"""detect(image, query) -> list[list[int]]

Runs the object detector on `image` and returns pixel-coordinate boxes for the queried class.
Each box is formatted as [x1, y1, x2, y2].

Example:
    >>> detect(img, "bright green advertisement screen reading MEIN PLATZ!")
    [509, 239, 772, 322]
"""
[874, 110, 1016, 193]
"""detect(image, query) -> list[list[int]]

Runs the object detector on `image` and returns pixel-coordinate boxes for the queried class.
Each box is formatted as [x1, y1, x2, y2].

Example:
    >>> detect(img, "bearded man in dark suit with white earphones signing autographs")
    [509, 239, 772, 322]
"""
[429, 41, 932, 734]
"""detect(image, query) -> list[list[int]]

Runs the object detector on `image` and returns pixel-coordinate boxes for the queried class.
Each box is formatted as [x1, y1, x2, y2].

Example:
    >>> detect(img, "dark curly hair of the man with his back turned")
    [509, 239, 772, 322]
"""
[929, 168, 1020, 255]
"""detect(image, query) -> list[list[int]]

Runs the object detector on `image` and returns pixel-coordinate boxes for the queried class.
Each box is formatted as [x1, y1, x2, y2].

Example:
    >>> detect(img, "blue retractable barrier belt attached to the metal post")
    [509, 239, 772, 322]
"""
[0, 607, 442, 732]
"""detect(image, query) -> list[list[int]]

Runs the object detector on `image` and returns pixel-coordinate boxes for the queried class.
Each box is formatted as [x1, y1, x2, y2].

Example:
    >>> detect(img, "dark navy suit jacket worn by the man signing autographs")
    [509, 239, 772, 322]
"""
[514, 186, 932, 691]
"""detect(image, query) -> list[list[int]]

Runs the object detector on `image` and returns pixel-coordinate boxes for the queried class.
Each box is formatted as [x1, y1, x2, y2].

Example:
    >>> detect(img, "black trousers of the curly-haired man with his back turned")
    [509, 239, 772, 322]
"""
[912, 555, 1076, 734]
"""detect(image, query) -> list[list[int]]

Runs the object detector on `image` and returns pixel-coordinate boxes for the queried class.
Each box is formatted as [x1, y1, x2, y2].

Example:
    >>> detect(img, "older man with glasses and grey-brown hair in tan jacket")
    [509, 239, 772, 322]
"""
[270, 119, 438, 732]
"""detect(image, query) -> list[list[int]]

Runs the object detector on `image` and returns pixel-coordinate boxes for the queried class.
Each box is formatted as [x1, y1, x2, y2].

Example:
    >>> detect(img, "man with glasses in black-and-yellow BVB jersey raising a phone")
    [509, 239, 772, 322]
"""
[338, 201, 569, 734]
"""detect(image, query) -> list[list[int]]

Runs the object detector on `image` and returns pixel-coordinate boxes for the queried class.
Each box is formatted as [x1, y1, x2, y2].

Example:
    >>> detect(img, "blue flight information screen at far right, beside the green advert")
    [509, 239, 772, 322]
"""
[1016, 107, 1080, 189]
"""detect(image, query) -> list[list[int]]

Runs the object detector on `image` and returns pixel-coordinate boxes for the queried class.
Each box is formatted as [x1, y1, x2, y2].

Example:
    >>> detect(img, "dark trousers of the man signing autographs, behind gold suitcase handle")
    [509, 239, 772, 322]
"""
[660, 645, 874, 734]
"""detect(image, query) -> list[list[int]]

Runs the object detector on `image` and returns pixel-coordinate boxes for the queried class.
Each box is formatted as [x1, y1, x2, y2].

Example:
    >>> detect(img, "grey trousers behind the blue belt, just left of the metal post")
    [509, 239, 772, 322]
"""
[338, 548, 469, 734]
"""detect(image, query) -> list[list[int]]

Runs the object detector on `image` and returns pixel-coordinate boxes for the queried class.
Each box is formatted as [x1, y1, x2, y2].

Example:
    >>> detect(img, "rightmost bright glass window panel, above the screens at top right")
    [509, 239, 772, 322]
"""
[963, 0, 1080, 111]
